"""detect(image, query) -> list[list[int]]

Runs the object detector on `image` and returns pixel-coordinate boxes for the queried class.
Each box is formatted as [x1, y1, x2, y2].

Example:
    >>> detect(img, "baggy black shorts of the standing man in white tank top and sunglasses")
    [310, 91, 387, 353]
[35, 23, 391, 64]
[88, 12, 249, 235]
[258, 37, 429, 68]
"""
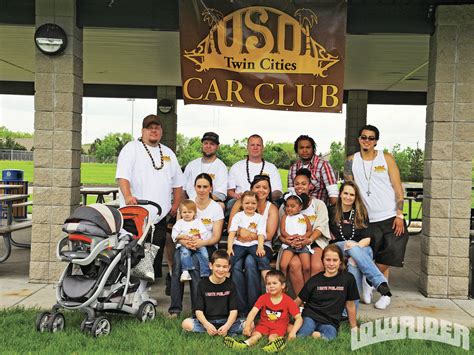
[369, 217, 408, 267]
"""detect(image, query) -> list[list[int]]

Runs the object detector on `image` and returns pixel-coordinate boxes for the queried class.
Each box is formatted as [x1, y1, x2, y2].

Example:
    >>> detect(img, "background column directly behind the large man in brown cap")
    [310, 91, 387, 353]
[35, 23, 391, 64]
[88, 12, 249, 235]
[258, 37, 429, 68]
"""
[157, 86, 178, 152]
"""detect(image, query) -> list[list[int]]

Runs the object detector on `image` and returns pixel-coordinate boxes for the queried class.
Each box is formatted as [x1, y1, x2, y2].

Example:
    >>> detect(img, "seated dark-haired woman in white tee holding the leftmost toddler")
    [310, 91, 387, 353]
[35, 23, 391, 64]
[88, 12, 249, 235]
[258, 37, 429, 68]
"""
[168, 173, 224, 318]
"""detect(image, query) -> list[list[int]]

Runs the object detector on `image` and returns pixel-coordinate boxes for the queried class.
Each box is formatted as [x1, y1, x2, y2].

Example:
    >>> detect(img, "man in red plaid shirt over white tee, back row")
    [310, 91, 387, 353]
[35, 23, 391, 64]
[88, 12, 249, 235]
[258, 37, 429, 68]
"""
[288, 135, 339, 205]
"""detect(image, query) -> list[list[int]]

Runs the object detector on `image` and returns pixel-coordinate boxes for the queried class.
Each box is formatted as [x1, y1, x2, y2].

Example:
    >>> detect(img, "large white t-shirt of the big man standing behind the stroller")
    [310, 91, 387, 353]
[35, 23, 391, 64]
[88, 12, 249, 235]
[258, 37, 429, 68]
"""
[115, 140, 184, 223]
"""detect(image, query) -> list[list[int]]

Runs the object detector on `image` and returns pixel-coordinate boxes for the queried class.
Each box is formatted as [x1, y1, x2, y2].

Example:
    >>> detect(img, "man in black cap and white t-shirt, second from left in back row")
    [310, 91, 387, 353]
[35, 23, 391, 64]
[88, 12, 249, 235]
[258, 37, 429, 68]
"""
[184, 132, 227, 202]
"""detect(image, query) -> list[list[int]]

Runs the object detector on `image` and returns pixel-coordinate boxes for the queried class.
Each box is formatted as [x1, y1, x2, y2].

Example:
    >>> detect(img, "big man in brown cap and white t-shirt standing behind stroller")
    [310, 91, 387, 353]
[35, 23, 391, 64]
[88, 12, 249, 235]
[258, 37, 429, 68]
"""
[115, 115, 183, 302]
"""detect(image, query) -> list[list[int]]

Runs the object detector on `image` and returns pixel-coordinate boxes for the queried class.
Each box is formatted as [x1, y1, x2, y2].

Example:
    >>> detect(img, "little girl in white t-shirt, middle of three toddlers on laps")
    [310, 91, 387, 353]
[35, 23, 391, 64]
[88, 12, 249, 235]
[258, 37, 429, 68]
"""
[227, 191, 270, 278]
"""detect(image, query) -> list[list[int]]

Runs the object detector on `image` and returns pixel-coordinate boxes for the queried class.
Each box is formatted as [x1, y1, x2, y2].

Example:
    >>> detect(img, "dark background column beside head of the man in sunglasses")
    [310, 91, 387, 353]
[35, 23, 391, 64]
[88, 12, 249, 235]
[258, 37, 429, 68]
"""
[344, 90, 368, 155]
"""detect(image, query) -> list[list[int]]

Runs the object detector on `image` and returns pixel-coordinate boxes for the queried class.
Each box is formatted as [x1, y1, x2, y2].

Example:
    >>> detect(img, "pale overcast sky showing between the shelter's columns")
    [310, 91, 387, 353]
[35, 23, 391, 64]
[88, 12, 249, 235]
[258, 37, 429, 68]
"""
[0, 95, 426, 153]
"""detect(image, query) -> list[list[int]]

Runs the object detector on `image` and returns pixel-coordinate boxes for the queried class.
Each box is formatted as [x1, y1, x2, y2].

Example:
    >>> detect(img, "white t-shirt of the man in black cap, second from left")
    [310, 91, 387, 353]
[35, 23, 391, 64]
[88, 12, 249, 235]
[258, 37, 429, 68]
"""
[184, 158, 227, 201]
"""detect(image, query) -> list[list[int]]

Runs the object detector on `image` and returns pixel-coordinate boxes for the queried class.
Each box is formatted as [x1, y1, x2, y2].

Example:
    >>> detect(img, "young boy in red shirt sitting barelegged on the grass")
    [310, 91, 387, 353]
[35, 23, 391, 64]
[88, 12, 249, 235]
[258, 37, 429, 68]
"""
[224, 270, 303, 352]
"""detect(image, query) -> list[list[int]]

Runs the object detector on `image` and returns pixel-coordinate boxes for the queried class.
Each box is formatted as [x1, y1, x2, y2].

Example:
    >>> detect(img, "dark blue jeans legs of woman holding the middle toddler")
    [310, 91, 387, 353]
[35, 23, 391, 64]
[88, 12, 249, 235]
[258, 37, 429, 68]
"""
[231, 255, 262, 315]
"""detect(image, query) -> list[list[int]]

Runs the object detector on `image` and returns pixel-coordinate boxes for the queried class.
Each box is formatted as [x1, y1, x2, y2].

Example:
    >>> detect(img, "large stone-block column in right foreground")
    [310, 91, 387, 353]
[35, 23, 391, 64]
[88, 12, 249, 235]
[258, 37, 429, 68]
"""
[420, 5, 474, 298]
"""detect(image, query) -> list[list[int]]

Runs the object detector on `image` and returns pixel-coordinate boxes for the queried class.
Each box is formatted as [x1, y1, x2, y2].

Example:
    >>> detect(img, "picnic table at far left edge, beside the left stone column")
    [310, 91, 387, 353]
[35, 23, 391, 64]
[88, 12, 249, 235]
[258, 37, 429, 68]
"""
[0, 194, 32, 263]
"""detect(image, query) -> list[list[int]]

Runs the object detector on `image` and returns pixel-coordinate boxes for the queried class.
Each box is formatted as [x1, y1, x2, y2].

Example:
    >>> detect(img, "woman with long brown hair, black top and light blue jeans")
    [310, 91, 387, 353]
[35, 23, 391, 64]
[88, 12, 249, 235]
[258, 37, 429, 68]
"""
[329, 181, 391, 303]
